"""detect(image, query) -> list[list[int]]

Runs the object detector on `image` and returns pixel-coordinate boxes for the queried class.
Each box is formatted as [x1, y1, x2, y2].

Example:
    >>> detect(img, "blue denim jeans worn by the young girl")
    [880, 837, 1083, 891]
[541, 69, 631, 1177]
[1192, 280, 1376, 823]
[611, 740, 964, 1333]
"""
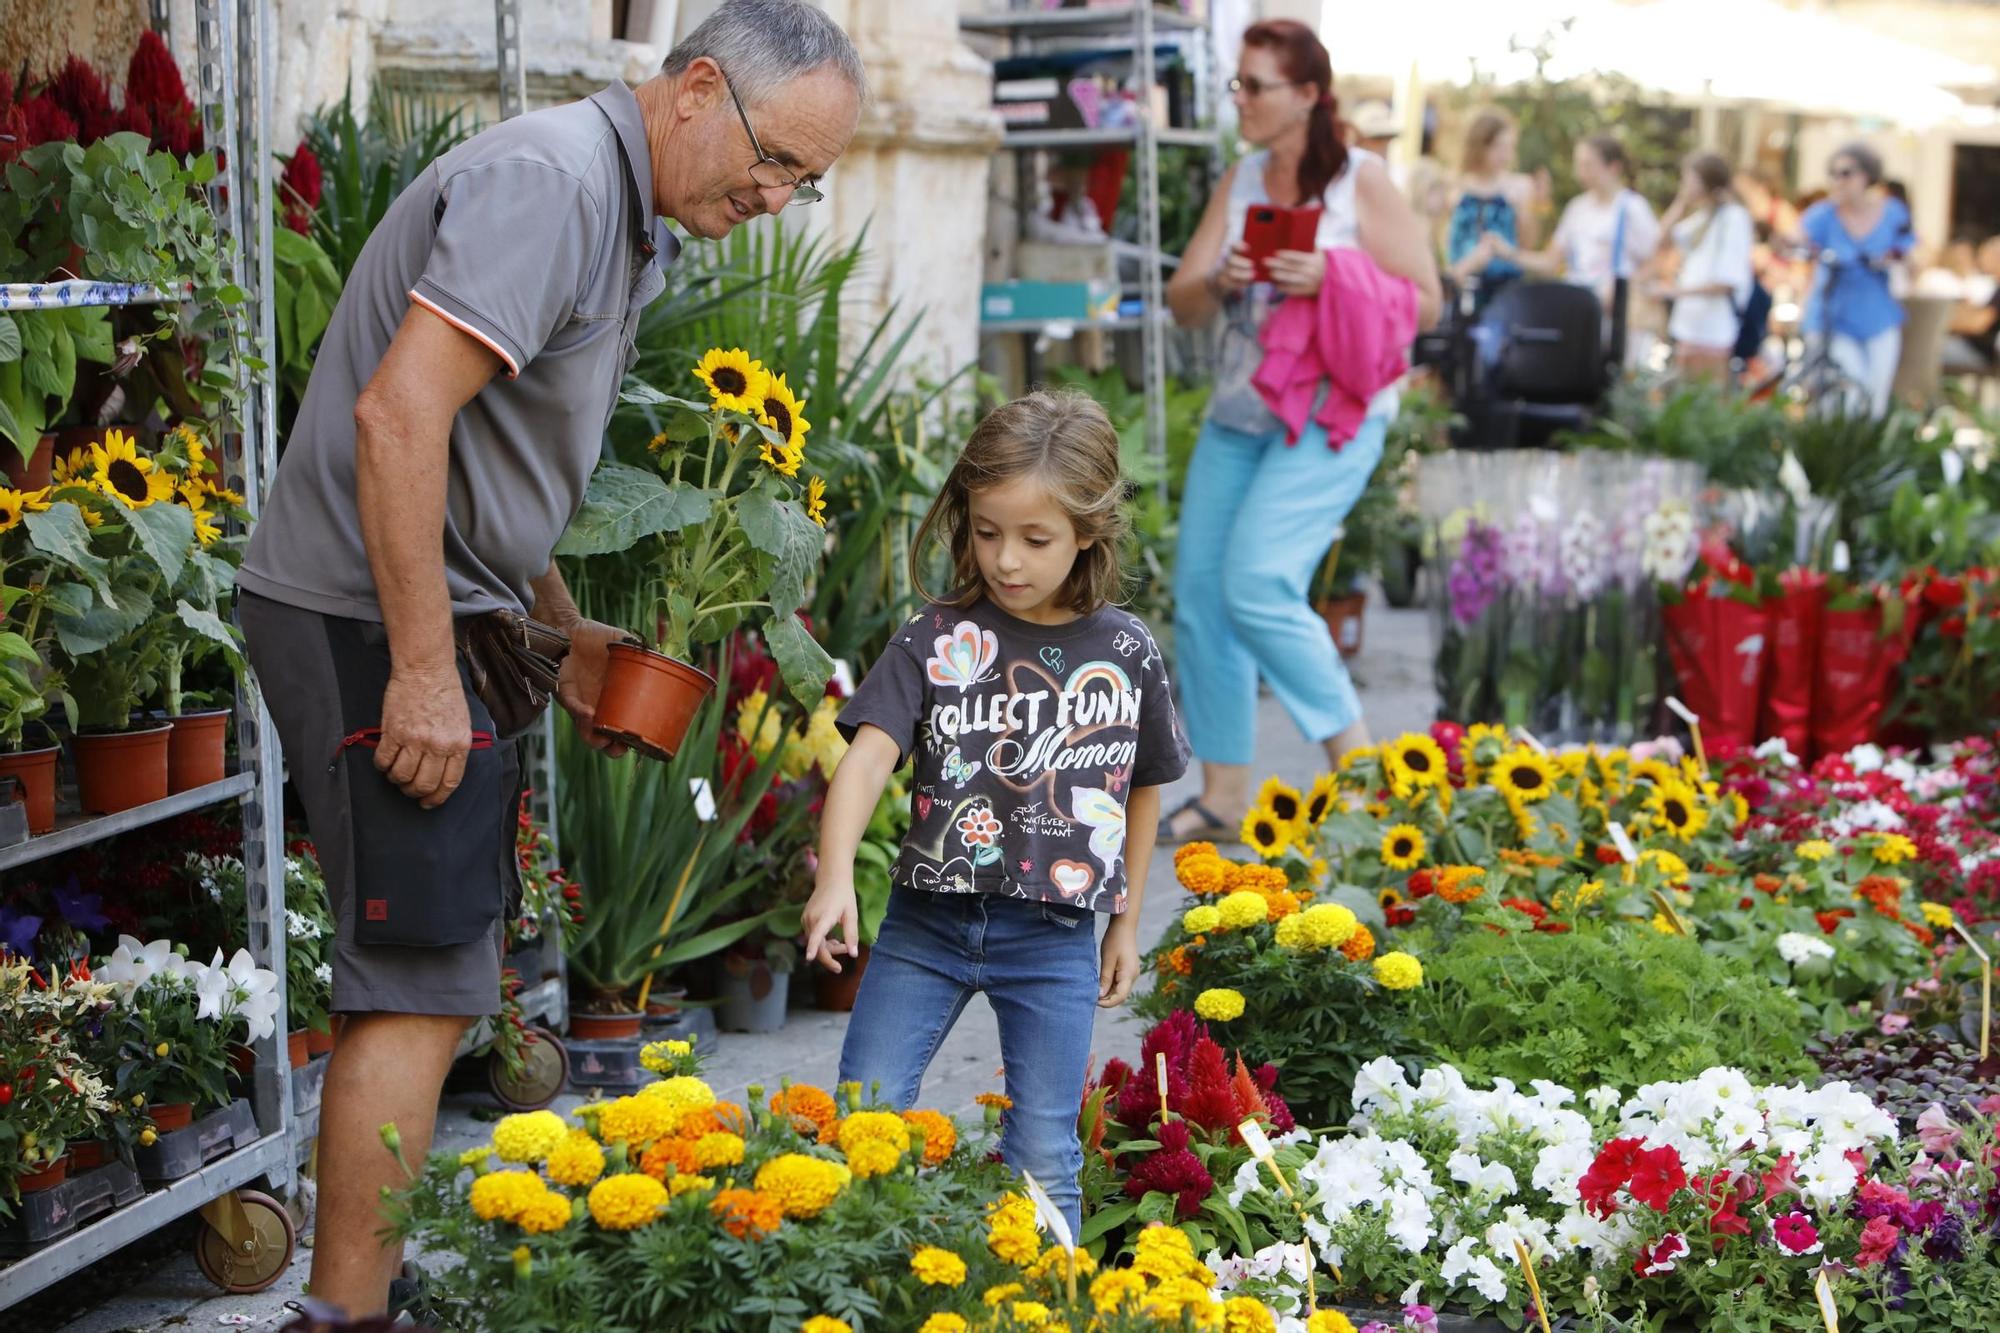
[840, 889, 1098, 1237]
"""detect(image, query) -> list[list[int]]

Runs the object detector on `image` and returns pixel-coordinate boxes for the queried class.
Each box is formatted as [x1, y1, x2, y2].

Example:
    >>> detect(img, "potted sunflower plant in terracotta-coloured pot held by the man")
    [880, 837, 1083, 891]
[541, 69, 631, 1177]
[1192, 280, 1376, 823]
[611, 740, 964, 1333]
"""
[556, 348, 832, 759]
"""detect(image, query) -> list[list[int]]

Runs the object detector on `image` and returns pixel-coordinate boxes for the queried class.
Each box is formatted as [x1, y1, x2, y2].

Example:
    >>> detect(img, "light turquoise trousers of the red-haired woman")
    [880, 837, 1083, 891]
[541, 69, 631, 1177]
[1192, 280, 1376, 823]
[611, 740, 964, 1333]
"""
[1174, 416, 1388, 765]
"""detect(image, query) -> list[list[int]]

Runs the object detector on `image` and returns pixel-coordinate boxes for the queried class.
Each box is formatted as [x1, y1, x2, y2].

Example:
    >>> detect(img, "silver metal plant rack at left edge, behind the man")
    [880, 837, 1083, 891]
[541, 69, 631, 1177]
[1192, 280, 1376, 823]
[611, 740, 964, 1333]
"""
[0, 0, 298, 1309]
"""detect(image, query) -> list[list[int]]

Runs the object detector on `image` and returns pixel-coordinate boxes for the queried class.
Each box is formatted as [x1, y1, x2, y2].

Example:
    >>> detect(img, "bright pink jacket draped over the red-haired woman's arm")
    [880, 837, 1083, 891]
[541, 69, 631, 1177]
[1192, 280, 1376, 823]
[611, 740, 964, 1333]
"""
[1250, 248, 1416, 448]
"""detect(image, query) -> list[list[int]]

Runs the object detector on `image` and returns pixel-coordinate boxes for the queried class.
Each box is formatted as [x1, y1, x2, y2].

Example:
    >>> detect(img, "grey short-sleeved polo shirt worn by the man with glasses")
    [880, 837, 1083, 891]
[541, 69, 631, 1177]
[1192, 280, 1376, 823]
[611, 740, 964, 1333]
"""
[238, 84, 680, 620]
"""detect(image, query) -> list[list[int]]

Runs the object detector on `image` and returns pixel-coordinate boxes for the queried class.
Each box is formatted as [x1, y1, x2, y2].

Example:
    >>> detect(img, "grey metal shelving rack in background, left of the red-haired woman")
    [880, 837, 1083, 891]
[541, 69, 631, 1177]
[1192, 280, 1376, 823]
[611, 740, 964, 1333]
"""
[958, 0, 1222, 472]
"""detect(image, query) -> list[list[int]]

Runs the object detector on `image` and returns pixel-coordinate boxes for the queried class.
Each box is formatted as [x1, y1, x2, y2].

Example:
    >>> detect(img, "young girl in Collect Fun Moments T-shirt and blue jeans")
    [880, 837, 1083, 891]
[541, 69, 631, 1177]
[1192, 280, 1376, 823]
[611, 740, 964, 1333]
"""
[804, 392, 1188, 1235]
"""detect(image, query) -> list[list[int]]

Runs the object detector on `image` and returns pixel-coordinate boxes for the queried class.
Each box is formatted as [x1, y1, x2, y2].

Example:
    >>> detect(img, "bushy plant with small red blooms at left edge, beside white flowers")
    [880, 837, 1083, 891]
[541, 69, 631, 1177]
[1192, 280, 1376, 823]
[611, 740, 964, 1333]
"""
[0, 951, 112, 1217]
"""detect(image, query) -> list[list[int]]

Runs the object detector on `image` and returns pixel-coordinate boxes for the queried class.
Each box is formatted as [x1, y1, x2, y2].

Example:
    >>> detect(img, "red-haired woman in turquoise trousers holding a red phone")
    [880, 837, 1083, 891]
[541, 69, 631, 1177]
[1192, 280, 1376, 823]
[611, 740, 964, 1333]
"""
[1162, 20, 1440, 839]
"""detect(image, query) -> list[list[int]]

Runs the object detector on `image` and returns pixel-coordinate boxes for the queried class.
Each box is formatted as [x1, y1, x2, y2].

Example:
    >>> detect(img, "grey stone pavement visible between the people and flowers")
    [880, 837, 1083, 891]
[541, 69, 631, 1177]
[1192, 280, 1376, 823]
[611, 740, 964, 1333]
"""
[39, 600, 1436, 1333]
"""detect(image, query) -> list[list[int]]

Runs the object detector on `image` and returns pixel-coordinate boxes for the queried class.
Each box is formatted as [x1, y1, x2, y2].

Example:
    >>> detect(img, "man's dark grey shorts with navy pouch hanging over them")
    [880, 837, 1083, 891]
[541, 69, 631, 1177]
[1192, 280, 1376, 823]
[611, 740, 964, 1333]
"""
[238, 592, 520, 1017]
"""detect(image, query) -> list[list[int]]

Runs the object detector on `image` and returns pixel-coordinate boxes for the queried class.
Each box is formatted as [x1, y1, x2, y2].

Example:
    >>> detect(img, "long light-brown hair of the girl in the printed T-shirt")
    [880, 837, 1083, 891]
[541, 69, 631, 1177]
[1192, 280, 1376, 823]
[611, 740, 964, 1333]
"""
[910, 390, 1132, 614]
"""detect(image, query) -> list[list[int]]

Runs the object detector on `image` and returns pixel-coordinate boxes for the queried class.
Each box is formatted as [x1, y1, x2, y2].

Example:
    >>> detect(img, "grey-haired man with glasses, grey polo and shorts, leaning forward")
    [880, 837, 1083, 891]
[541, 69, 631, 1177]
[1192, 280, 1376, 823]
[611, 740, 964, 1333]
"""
[242, 0, 864, 1315]
